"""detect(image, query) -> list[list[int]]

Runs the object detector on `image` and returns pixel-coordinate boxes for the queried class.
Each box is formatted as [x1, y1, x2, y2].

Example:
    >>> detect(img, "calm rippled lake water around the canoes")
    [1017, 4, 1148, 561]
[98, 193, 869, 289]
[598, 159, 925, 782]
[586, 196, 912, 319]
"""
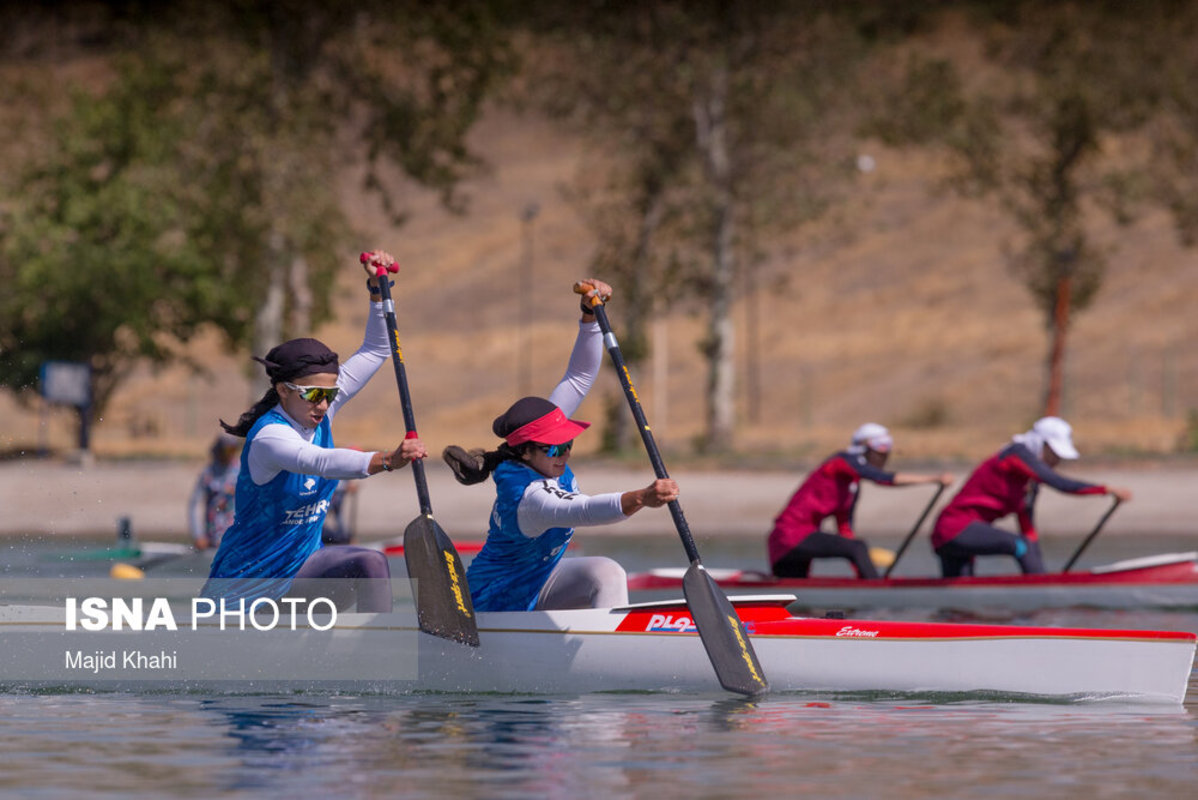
[0, 537, 1198, 798]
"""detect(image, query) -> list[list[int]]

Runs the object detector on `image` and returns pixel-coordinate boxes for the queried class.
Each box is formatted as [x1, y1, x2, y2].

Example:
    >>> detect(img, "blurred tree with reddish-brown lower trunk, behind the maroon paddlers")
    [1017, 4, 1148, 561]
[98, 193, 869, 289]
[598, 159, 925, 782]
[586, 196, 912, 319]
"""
[871, 1, 1176, 414]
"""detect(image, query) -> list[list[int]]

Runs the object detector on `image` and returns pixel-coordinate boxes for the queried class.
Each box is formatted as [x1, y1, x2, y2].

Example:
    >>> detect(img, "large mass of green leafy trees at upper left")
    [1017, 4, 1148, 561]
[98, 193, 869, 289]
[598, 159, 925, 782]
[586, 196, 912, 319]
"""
[0, 0, 510, 438]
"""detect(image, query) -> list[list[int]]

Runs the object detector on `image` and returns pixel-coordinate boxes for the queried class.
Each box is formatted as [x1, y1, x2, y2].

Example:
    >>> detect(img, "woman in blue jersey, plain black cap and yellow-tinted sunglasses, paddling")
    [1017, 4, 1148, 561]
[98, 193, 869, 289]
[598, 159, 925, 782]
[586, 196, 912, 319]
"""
[202, 251, 428, 611]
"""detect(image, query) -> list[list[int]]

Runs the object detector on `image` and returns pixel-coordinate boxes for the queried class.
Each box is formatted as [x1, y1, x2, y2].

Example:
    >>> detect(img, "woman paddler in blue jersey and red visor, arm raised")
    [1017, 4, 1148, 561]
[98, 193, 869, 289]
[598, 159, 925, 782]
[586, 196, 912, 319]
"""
[442, 278, 678, 611]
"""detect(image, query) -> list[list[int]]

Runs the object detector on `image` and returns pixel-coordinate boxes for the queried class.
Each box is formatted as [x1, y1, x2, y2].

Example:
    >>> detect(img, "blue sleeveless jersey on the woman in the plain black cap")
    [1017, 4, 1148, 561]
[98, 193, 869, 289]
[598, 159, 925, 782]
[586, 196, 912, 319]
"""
[201, 410, 338, 600]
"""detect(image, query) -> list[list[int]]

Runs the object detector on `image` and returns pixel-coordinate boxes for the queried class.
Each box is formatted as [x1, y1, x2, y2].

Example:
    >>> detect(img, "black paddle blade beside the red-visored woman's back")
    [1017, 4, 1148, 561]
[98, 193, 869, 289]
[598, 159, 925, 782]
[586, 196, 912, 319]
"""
[404, 516, 478, 647]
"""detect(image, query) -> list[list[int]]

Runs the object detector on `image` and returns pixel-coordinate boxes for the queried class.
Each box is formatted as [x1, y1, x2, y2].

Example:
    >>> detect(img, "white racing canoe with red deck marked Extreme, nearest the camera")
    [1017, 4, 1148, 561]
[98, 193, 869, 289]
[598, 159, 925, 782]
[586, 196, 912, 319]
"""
[0, 595, 1196, 704]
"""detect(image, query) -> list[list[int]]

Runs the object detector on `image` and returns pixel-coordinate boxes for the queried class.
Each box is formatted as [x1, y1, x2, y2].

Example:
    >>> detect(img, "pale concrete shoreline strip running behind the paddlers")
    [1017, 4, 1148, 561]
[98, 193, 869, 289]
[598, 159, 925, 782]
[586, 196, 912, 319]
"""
[0, 457, 1198, 544]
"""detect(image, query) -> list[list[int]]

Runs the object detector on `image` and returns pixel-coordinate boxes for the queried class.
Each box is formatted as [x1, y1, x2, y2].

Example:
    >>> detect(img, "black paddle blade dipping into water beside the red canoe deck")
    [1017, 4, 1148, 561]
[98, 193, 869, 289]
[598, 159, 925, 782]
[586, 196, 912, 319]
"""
[682, 562, 769, 697]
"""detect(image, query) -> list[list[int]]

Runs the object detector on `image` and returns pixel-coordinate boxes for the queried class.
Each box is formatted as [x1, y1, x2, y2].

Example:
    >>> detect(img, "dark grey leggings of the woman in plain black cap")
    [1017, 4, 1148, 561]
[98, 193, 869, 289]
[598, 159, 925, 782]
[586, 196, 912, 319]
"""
[288, 545, 391, 612]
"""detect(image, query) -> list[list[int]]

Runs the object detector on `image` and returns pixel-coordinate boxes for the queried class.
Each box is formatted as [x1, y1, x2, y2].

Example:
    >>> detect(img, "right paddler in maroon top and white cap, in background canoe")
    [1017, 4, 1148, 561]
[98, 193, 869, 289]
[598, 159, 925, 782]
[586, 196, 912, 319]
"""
[932, 417, 1131, 577]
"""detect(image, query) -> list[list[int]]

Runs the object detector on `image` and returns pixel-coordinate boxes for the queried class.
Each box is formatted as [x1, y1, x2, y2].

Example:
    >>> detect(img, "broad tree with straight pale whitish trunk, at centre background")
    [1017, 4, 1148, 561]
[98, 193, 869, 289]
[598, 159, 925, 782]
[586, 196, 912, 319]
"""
[527, 0, 863, 450]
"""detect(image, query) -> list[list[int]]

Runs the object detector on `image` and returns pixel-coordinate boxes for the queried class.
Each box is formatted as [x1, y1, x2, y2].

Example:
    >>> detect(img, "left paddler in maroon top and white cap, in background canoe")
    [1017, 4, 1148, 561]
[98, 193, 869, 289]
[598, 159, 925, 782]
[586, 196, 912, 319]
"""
[768, 423, 952, 578]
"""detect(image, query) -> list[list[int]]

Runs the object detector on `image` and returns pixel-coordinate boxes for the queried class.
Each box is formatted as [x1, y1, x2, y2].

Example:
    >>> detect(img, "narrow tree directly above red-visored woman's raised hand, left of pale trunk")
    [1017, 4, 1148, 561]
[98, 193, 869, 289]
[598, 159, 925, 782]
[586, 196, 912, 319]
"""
[525, 13, 698, 450]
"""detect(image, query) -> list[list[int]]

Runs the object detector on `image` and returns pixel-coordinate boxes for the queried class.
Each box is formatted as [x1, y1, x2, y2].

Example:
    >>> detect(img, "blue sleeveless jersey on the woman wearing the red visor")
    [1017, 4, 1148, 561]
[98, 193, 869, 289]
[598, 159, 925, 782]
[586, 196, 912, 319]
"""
[464, 461, 579, 611]
